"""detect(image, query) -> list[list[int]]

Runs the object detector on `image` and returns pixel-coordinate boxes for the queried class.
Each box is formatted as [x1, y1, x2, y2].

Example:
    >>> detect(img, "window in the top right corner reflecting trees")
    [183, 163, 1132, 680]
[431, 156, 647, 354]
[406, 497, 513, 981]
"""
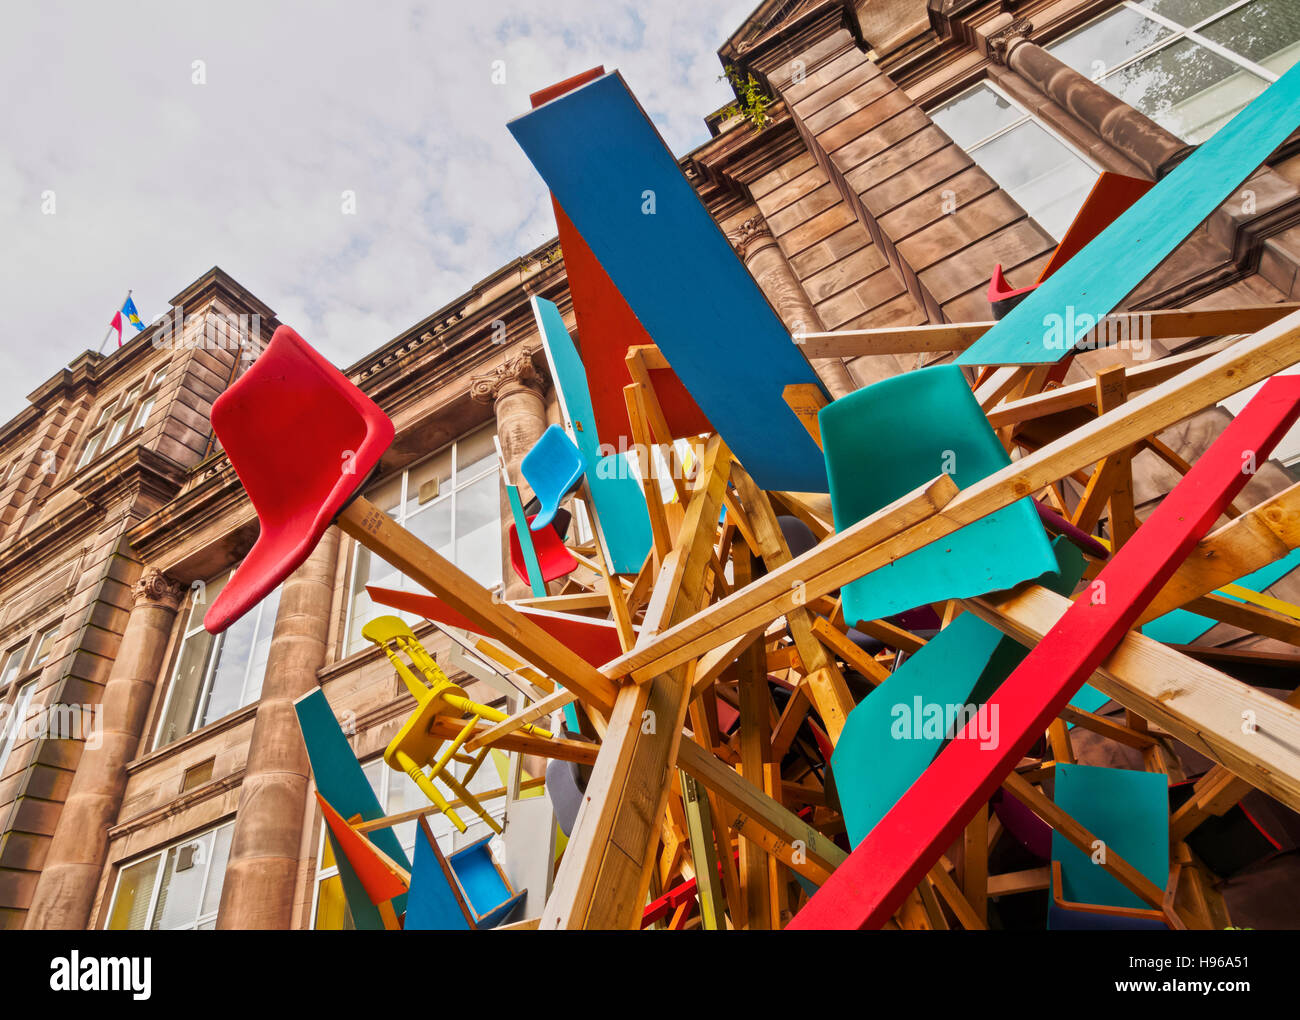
[1048, 0, 1300, 142]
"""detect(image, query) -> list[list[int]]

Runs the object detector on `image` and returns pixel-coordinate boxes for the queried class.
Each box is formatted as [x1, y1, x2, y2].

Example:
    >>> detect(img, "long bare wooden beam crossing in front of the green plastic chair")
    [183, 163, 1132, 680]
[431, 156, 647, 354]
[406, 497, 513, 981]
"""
[602, 312, 1300, 682]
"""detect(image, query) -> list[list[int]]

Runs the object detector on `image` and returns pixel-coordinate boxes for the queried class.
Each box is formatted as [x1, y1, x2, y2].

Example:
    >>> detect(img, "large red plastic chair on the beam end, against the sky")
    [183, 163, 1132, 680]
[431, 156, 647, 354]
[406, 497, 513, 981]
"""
[203, 326, 393, 634]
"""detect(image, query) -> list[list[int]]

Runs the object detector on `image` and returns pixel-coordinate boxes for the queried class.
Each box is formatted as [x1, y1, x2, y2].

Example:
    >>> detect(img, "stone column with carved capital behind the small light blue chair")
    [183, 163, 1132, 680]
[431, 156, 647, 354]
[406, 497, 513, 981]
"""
[469, 346, 547, 599]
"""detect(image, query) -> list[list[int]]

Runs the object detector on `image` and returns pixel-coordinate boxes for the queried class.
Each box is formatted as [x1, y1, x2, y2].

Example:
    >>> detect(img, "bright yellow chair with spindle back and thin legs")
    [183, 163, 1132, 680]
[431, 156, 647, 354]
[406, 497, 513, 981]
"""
[361, 616, 551, 833]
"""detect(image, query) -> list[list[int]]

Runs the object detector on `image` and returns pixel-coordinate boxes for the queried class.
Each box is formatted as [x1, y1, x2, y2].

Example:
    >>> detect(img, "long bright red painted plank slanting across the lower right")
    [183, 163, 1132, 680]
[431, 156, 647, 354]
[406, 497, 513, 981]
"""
[789, 376, 1300, 929]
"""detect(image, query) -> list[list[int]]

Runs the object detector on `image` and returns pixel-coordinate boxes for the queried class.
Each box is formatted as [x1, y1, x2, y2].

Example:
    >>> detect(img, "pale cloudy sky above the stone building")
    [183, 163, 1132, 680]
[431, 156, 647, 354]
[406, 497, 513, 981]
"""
[0, 0, 758, 421]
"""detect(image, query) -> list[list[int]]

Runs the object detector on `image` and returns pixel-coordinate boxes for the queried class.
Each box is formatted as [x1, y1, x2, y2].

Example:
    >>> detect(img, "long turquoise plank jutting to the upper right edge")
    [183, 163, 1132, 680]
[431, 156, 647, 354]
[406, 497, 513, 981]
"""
[957, 64, 1300, 365]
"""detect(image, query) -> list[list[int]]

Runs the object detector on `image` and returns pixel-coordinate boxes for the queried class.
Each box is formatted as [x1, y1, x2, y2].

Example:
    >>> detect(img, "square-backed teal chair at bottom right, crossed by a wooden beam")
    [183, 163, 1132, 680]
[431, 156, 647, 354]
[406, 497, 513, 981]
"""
[1048, 764, 1169, 930]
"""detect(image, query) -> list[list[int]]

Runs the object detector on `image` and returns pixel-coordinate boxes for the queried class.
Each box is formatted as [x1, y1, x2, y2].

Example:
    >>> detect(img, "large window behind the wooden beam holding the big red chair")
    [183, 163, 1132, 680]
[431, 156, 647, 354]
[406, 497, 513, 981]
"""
[345, 427, 501, 655]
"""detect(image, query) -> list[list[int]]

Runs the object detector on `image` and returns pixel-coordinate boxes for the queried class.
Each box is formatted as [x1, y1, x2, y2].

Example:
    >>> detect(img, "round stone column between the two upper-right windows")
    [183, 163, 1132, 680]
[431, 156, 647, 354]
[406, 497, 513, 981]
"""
[976, 14, 1192, 181]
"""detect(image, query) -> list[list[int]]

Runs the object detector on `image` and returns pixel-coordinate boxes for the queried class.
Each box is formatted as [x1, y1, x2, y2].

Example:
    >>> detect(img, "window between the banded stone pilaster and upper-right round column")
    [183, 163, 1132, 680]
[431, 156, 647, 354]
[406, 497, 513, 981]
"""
[930, 82, 1097, 239]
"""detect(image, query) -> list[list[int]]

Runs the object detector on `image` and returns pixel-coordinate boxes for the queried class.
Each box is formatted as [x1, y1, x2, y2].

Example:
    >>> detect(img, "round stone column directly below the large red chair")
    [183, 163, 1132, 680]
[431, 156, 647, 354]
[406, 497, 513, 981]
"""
[217, 528, 339, 929]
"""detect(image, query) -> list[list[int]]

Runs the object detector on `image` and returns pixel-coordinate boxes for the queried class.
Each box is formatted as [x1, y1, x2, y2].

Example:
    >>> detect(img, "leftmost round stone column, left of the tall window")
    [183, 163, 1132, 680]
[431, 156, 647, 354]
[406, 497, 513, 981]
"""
[27, 567, 185, 929]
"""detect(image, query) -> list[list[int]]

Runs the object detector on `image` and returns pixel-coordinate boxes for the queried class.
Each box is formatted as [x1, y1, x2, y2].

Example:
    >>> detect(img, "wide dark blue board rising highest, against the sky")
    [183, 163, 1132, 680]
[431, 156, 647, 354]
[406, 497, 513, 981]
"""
[508, 73, 827, 492]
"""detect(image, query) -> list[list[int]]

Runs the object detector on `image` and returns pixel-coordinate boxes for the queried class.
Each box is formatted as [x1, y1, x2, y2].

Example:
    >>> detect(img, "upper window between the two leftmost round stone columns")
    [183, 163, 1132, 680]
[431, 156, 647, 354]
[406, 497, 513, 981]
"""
[153, 570, 281, 747]
